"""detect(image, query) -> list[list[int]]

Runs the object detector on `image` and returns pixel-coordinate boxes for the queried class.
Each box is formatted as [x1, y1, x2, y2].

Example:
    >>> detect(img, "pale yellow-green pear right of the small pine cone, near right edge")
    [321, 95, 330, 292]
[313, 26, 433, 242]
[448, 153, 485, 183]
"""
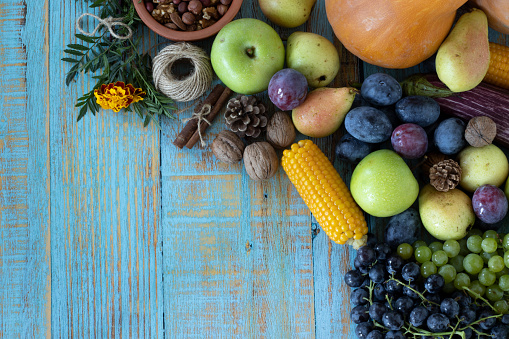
[458, 144, 509, 193]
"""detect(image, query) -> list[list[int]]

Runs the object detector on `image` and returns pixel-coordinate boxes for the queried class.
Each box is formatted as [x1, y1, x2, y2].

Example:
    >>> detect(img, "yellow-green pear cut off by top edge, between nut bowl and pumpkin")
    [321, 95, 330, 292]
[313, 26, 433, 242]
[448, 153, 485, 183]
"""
[258, 0, 316, 28]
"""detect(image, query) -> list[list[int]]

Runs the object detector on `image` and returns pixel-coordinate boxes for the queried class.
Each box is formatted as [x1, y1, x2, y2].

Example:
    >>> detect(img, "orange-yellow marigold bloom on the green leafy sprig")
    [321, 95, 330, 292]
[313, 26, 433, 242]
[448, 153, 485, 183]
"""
[94, 81, 147, 112]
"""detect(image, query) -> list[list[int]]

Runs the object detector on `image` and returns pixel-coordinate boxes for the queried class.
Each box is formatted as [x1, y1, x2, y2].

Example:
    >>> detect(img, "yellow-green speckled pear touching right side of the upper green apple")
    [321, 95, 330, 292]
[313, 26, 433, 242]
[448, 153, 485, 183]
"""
[286, 32, 339, 88]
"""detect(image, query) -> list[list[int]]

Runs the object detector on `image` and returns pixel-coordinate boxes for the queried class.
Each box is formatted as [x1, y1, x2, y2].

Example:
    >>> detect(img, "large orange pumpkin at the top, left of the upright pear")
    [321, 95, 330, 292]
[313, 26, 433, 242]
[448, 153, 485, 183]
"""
[325, 0, 468, 68]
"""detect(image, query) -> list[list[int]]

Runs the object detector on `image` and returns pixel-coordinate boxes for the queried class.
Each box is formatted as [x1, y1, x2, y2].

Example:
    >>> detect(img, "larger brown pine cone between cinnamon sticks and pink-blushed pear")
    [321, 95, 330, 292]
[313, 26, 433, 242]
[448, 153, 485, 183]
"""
[224, 95, 267, 139]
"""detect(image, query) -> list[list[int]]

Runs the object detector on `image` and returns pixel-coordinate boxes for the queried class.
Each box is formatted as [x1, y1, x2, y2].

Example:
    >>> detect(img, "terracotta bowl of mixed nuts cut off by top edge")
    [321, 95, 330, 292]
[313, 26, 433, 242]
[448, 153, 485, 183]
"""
[133, 0, 242, 41]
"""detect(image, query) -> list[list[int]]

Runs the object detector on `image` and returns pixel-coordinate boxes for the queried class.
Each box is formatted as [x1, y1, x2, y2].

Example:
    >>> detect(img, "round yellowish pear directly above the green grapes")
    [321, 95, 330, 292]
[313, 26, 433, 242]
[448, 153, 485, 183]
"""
[419, 184, 475, 240]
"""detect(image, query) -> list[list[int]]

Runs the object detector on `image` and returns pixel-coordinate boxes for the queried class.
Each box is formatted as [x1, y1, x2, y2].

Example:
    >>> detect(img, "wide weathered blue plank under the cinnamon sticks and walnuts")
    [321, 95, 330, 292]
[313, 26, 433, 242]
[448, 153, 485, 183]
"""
[161, 1, 315, 338]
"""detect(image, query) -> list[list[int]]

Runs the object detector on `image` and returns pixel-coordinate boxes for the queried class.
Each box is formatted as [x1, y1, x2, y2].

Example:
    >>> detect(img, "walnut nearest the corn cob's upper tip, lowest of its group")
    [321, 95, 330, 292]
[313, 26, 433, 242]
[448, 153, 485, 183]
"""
[244, 141, 279, 181]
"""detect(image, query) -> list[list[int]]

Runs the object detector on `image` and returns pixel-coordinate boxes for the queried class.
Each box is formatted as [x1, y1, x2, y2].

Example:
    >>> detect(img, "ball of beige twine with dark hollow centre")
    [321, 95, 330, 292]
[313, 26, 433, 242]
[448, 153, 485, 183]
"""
[152, 42, 214, 102]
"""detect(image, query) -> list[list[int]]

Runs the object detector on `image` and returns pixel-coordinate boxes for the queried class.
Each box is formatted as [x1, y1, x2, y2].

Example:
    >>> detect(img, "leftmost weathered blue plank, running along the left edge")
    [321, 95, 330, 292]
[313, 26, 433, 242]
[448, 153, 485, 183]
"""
[0, 1, 51, 338]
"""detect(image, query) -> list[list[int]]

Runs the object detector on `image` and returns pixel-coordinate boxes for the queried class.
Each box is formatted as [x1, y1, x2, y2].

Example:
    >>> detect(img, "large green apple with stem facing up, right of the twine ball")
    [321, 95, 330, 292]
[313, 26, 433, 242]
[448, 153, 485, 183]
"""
[210, 18, 285, 94]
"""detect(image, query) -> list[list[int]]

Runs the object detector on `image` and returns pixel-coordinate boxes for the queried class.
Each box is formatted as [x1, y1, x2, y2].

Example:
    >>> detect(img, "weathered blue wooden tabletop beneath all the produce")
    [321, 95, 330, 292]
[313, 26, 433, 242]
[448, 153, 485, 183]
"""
[0, 0, 507, 338]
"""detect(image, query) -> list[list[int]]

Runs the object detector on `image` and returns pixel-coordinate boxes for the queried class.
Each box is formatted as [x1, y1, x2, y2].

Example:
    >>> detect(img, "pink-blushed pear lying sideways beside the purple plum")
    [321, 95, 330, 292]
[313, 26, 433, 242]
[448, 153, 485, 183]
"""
[292, 87, 357, 138]
